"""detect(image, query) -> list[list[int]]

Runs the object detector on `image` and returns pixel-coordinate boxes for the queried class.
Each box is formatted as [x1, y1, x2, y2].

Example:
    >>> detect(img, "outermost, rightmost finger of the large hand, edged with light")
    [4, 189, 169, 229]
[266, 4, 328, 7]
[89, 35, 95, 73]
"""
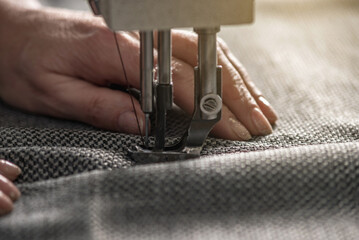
[218, 39, 278, 124]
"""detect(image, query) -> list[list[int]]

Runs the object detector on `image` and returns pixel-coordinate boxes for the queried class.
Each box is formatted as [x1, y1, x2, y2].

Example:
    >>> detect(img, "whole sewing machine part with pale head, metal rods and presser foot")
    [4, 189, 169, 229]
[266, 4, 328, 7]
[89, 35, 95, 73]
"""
[89, 0, 254, 162]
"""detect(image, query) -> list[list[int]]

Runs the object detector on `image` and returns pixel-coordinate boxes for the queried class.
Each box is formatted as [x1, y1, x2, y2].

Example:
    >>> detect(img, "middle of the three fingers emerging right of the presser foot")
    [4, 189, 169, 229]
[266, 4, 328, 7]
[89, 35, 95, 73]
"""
[218, 51, 272, 135]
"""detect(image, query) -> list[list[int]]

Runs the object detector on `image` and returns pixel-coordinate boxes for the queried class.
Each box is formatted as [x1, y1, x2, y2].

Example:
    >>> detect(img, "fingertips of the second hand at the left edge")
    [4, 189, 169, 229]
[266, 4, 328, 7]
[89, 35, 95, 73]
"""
[0, 160, 21, 216]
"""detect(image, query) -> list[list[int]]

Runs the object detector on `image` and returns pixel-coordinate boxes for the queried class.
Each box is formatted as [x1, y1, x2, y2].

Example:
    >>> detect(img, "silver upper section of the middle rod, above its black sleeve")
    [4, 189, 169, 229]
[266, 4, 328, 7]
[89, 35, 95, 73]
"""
[158, 30, 172, 84]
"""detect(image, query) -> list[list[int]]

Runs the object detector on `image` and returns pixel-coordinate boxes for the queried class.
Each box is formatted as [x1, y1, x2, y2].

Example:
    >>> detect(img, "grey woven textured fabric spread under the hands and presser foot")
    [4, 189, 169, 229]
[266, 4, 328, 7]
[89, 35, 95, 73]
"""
[0, 0, 359, 240]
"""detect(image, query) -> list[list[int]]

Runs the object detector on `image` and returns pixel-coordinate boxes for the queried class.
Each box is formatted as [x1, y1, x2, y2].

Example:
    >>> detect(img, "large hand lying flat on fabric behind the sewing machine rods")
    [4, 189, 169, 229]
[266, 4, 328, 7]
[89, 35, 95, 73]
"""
[0, 4, 277, 140]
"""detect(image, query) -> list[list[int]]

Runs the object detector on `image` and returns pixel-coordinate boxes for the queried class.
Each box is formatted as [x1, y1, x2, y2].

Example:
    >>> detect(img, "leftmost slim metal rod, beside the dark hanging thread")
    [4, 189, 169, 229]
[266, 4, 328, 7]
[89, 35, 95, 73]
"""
[140, 31, 153, 113]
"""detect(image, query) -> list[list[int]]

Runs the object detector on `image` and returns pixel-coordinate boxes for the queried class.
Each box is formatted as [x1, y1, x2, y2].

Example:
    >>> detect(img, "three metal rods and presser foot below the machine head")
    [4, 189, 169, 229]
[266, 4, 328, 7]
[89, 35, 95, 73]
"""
[130, 27, 222, 163]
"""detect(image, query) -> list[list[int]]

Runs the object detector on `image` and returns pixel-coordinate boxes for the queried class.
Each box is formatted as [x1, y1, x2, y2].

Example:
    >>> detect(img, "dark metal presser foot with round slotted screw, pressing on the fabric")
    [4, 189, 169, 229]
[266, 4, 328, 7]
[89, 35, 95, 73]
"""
[129, 67, 222, 163]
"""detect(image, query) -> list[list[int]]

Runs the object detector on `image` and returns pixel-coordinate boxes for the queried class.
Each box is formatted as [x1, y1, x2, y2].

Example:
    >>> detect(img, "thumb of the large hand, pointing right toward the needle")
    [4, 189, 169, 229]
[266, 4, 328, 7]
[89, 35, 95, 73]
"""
[37, 74, 144, 134]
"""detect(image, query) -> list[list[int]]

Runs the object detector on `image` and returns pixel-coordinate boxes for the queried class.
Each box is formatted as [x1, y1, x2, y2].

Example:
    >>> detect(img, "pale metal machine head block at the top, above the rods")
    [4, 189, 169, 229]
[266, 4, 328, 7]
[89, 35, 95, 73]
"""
[97, 0, 254, 31]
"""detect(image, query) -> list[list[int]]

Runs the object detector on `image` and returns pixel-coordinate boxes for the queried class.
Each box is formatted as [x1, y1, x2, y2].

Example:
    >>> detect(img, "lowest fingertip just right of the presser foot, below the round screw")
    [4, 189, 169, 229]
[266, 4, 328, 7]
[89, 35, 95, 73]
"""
[211, 105, 252, 141]
